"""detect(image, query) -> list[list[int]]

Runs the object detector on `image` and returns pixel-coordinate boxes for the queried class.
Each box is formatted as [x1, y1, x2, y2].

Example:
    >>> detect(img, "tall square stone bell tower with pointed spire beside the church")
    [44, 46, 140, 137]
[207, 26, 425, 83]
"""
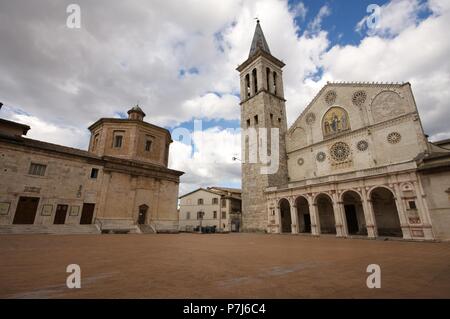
[236, 20, 288, 231]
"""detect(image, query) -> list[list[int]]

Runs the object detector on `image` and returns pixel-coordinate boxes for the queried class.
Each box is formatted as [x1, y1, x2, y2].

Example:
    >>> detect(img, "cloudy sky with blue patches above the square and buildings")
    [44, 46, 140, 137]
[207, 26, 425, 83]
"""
[0, 0, 450, 194]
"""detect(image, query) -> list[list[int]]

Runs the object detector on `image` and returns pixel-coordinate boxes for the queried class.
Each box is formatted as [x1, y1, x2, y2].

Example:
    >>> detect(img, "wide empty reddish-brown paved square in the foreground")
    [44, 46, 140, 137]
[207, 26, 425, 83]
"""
[0, 234, 450, 298]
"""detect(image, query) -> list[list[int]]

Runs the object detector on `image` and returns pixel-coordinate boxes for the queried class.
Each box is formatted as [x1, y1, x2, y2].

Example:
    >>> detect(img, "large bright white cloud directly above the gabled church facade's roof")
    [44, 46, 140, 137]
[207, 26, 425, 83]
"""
[322, 1, 450, 138]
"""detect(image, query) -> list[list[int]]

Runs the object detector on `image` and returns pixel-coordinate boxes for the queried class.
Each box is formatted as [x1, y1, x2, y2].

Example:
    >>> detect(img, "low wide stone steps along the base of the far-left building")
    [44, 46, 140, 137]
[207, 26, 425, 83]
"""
[0, 224, 100, 235]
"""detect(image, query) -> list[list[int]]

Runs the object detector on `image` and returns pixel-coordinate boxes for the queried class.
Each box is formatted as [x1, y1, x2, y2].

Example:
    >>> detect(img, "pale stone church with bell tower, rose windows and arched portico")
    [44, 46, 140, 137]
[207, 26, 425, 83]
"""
[237, 21, 450, 240]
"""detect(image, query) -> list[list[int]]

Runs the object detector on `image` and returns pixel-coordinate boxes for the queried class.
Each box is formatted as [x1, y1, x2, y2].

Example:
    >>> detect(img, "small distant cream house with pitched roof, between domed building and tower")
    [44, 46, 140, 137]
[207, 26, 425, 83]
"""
[179, 187, 241, 232]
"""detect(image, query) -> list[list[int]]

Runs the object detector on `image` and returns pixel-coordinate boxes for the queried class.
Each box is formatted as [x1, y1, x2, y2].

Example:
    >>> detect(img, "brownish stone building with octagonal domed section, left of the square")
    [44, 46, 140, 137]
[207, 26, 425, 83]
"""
[0, 106, 183, 233]
